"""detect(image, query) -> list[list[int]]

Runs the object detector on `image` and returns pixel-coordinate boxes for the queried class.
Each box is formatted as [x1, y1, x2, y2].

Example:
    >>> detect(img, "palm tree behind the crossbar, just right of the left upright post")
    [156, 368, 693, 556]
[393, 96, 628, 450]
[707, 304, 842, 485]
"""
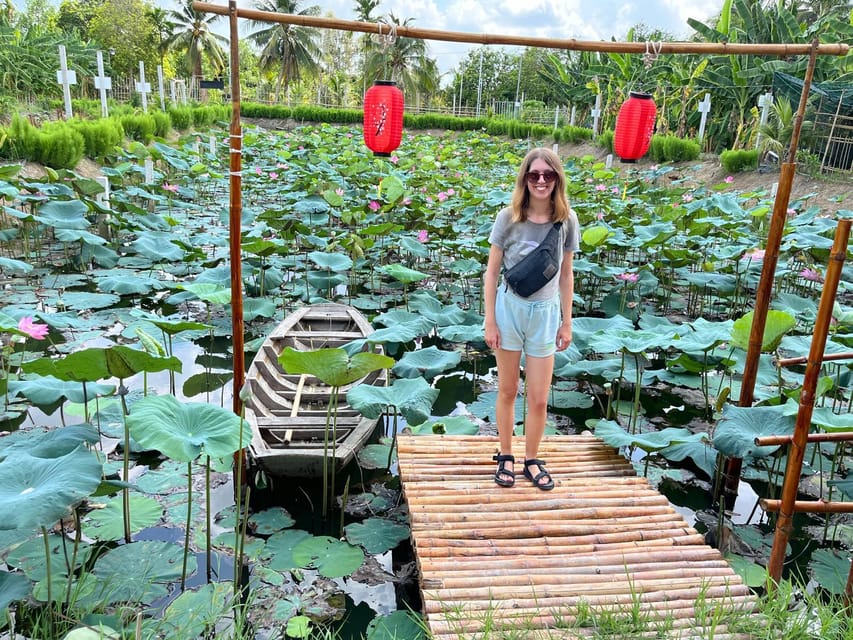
[249, 0, 322, 98]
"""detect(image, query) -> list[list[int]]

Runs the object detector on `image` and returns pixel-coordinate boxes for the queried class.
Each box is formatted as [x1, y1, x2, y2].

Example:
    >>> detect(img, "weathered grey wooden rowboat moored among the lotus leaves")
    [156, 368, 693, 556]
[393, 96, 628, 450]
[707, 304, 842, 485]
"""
[245, 303, 387, 478]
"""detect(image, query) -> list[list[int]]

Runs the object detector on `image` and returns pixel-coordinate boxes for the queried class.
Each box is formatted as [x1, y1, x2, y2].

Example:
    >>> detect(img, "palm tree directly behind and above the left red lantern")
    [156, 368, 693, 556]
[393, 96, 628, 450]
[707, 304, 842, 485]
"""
[365, 13, 439, 103]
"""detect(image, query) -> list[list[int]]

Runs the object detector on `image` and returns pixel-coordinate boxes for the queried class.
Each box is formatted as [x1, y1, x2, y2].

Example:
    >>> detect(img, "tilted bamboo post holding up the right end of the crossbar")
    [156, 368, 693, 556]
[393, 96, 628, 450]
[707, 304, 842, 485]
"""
[717, 40, 823, 512]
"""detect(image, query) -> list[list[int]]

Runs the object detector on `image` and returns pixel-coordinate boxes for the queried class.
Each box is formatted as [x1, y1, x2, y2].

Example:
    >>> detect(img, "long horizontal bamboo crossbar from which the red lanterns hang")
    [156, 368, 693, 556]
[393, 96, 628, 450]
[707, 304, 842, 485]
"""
[188, 2, 849, 57]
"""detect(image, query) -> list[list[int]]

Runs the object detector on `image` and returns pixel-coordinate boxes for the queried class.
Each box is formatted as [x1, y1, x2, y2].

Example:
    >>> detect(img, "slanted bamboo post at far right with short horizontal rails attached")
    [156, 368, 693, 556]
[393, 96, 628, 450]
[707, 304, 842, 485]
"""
[767, 219, 851, 583]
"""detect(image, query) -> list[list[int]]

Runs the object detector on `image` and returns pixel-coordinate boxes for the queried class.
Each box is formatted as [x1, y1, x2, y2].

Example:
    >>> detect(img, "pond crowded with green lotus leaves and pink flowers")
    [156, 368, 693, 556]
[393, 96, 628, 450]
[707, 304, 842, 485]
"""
[0, 125, 853, 639]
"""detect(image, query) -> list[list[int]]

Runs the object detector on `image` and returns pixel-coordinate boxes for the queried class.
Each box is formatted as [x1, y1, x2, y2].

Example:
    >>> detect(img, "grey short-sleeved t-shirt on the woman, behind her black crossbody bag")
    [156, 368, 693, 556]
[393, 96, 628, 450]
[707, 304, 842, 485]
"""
[489, 207, 580, 300]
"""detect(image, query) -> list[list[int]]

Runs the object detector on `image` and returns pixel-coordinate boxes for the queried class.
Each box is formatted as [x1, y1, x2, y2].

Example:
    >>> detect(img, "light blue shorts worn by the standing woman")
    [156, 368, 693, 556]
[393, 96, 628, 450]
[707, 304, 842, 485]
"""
[495, 284, 562, 358]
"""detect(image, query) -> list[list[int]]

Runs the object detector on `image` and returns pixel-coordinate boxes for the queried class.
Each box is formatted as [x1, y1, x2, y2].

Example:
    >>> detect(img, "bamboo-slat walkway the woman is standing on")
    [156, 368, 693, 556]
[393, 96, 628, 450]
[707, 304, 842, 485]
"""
[397, 435, 754, 640]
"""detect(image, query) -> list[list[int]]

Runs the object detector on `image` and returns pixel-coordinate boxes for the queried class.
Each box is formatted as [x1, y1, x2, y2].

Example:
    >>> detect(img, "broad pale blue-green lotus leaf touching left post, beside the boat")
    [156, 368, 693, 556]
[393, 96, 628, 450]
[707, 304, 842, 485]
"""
[127, 395, 252, 462]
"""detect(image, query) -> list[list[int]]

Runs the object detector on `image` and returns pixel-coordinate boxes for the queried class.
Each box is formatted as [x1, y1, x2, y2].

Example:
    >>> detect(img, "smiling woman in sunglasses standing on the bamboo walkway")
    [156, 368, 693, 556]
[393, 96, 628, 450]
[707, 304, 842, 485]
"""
[484, 148, 579, 491]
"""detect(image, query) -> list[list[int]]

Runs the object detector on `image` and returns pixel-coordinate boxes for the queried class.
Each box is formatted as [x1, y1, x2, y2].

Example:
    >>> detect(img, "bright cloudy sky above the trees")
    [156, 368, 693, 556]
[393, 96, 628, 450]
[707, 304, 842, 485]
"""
[14, 0, 723, 80]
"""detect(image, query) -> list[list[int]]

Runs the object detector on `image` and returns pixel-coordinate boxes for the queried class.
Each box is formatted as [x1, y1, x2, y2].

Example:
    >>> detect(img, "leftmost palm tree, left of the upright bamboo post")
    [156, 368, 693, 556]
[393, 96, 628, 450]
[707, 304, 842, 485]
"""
[163, 0, 228, 90]
